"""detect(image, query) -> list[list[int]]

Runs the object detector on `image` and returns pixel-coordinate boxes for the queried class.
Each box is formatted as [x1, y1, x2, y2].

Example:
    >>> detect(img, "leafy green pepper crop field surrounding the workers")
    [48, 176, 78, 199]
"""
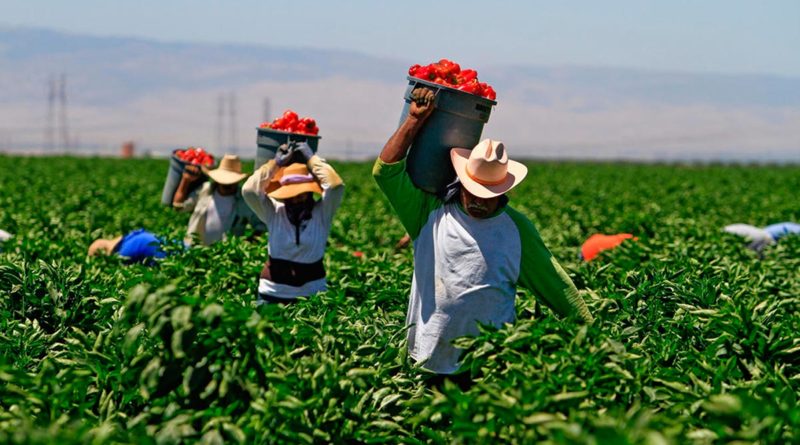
[0, 156, 800, 444]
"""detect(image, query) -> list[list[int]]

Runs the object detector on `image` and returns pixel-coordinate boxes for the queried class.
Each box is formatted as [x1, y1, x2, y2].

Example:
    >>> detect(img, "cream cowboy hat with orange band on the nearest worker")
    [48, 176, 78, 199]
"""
[450, 139, 528, 199]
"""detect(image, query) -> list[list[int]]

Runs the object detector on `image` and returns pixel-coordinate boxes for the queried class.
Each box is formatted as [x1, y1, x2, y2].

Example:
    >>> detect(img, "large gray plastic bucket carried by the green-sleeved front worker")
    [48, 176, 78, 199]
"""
[400, 76, 497, 194]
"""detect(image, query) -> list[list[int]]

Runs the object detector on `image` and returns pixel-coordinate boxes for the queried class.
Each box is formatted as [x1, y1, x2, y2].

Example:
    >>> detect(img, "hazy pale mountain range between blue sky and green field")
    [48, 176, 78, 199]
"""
[0, 27, 800, 161]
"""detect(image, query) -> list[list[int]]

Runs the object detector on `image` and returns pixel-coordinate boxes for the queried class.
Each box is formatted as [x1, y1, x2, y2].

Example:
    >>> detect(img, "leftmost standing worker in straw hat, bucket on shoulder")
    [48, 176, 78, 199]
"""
[172, 155, 266, 246]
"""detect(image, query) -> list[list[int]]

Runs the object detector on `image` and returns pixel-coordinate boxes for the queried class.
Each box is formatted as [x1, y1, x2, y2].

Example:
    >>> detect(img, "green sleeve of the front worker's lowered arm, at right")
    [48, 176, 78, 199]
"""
[506, 207, 594, 323]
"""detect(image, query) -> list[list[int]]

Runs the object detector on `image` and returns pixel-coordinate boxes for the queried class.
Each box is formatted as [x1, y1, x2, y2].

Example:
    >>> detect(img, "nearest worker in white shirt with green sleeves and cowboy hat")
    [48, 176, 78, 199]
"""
[373, 88, 593, 375]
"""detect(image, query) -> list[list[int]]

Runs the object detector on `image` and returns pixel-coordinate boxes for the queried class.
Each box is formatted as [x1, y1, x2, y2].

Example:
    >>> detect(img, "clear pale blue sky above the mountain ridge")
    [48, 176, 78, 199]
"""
[0, 0, 800, 76]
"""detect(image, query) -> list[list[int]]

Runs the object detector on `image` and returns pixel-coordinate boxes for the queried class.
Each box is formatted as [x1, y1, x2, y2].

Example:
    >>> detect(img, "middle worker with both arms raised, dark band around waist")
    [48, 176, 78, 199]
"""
[242, 143, 344, 304]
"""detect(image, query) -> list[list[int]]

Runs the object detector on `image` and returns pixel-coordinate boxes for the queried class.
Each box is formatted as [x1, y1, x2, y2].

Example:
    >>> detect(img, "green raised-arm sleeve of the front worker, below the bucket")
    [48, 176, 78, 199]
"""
[372, 158, 442, 239]
